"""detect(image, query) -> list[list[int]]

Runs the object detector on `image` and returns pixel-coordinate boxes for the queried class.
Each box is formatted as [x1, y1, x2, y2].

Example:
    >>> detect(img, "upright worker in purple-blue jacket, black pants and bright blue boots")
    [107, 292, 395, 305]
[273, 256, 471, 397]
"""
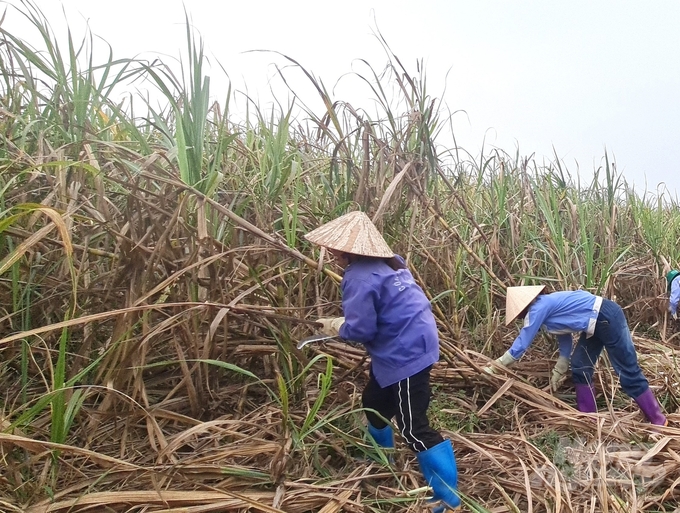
[305, 211, 461, 513]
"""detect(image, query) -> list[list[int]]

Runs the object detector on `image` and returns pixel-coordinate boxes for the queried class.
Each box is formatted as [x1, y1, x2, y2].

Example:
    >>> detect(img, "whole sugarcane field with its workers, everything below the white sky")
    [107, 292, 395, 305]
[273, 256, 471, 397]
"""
[0, 0, 680, 513]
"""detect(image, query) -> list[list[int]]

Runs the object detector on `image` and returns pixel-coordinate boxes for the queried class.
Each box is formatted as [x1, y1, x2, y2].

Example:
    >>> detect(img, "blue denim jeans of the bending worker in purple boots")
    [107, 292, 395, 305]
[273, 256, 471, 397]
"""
[571, 299, 649, 399]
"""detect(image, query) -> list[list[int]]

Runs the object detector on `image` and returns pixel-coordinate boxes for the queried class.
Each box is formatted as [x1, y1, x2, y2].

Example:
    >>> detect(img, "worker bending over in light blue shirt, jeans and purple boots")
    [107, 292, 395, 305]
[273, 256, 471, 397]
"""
[484, 285, 668, 426]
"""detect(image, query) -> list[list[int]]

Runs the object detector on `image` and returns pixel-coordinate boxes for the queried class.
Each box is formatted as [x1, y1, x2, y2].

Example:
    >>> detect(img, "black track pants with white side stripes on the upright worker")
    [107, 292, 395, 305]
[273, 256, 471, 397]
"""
[361, 366, 444, 452]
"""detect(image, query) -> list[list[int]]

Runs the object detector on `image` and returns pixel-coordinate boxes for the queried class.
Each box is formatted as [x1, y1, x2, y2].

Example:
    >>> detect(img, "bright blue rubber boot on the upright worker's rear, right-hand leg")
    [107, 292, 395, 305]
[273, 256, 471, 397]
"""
[416, 440, 460, 513]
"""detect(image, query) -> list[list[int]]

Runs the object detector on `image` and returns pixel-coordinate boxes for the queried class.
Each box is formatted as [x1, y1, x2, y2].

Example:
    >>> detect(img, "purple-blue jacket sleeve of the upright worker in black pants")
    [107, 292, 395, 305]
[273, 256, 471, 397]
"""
[340, 279, 378, 344]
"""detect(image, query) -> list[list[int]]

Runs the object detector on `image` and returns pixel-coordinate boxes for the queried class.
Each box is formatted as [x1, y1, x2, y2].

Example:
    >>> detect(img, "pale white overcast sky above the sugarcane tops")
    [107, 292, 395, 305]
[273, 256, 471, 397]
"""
[3, 0, 680, 193]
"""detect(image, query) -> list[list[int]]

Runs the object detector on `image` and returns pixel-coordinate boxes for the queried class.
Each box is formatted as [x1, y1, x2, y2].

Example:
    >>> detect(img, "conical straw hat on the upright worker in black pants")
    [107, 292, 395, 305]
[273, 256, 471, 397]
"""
[305, 210, 394, 258]
